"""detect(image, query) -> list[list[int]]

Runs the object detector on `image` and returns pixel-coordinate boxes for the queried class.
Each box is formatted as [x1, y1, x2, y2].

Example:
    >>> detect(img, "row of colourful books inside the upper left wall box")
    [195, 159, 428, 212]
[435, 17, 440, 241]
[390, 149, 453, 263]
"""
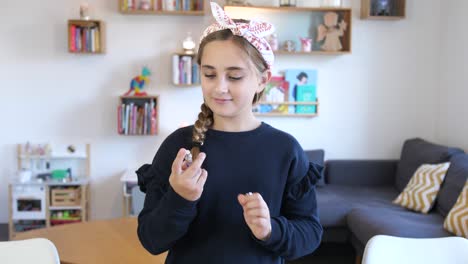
[70, 25, 101, 52]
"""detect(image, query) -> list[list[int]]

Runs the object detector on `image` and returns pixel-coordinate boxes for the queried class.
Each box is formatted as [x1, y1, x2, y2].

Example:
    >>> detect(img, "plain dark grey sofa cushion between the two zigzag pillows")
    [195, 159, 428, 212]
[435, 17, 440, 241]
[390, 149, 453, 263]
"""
[436, 154, 468, 216]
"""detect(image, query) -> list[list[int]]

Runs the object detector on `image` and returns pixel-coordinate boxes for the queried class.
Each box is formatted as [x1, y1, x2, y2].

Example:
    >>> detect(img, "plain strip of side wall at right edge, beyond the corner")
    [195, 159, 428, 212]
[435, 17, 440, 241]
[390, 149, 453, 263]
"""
[437, 0, 468, 151]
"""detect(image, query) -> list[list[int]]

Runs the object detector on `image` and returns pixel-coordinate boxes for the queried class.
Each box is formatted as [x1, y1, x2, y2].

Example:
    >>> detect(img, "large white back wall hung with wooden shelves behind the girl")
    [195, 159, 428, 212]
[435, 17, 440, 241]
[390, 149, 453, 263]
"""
[0, 0, 446, 222]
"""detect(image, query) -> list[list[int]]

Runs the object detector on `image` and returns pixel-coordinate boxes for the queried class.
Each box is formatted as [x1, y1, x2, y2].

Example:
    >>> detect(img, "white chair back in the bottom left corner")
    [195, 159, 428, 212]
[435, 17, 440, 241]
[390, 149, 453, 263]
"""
[0, 238, 60, 264]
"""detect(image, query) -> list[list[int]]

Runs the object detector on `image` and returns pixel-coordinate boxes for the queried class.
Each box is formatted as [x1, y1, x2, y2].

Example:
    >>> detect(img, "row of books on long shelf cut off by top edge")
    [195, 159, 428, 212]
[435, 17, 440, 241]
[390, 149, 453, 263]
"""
[123, 0, 203, 11]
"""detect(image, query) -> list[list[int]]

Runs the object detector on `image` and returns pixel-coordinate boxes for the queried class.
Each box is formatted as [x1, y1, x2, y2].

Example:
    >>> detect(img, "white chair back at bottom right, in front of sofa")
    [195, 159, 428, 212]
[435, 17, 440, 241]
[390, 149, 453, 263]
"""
[362, 235, 468, 264]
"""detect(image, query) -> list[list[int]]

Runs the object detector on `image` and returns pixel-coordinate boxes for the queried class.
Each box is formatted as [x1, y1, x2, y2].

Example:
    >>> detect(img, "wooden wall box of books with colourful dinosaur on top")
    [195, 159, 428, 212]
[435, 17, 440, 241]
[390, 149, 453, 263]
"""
[117, 95, 159, 136]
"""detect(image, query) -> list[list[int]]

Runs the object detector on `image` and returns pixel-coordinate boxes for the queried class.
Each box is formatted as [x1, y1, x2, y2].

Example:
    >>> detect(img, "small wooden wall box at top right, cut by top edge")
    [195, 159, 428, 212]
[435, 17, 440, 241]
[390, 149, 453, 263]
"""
[361, 0, 406, 20]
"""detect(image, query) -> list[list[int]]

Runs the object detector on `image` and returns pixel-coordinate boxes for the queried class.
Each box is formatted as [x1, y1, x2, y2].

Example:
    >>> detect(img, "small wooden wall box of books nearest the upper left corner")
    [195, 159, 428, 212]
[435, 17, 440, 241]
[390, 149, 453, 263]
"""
[68, 20, 105, 54]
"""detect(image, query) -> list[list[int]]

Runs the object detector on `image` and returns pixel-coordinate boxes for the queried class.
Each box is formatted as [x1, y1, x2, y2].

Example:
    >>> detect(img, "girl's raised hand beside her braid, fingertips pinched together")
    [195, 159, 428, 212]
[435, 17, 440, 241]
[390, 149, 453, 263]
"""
[169, 148, 208, 201]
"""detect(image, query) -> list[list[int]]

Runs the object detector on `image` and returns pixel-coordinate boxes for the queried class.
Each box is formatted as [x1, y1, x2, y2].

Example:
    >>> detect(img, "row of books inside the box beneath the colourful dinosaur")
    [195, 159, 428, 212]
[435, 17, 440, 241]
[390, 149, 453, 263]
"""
[117, 101, 157, 135]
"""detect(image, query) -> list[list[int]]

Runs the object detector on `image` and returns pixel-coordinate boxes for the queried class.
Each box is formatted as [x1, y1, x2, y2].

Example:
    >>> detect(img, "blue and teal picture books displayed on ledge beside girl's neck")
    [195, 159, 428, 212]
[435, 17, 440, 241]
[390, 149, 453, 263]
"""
[254, 69, 317, 114]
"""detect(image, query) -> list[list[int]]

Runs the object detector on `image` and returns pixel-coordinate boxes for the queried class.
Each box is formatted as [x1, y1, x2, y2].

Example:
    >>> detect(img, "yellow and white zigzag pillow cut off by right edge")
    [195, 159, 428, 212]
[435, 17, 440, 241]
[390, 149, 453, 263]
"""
[444, 180, 468, 238]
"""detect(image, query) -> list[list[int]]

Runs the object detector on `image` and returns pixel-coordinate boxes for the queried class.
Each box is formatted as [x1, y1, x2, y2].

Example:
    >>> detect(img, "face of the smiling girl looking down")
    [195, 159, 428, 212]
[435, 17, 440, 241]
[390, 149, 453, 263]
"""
[201, 40, 268, 120]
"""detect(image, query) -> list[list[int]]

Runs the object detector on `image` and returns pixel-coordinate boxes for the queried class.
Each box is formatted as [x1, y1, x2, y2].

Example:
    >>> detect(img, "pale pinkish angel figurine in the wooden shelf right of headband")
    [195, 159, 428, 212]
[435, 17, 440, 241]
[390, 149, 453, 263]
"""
[317, 12, 346, 51]
